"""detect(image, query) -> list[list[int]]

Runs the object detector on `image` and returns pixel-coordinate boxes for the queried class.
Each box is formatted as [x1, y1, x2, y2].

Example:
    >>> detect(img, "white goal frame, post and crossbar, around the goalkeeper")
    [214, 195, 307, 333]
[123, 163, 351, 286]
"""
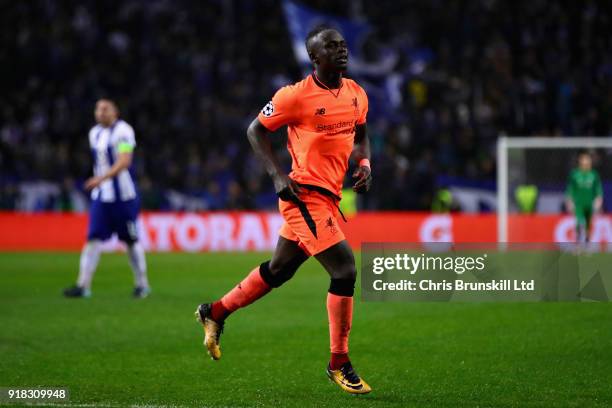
[497, 136, 612, 243]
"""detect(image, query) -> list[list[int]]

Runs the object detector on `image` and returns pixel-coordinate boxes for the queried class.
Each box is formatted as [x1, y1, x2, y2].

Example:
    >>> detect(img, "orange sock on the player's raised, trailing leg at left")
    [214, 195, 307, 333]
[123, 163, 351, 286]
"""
[213, 266, 271, 321]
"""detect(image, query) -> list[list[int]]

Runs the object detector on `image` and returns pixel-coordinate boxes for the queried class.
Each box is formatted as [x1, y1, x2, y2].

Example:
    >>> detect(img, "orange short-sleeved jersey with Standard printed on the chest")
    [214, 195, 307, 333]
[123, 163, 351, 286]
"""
[258, 75, 368, 196]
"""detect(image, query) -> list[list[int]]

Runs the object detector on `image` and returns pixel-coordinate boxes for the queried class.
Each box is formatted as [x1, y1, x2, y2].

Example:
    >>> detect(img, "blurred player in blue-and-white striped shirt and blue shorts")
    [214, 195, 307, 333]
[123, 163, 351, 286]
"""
[64, 99, 150, 298]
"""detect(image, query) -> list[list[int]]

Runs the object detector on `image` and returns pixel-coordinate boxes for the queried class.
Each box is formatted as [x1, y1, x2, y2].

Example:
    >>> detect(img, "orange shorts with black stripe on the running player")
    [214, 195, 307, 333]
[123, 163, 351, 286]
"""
[278, 189, 345, 256]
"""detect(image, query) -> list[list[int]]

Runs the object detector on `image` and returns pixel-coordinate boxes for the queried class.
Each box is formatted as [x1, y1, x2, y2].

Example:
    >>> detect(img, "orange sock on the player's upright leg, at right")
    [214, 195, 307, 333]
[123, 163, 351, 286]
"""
[327, 292, 353, 370]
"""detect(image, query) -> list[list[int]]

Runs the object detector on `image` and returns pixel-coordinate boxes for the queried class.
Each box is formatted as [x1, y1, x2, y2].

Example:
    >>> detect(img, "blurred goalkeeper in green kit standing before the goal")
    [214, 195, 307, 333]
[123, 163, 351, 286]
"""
[565, 152, 603, 242]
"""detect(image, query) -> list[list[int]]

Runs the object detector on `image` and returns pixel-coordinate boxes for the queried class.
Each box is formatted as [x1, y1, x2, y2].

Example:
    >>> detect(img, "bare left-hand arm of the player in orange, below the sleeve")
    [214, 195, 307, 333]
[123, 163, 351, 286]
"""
[247, 118, 300, 201]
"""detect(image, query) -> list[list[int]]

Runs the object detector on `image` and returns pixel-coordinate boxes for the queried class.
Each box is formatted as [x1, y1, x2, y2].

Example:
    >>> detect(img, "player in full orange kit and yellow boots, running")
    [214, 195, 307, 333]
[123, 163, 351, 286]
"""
[196, 26, 372, 394]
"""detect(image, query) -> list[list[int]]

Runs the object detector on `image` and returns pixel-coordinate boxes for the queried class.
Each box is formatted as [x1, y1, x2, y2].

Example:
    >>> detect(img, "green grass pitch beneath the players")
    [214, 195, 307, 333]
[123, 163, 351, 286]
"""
[0, 253, 612, 408]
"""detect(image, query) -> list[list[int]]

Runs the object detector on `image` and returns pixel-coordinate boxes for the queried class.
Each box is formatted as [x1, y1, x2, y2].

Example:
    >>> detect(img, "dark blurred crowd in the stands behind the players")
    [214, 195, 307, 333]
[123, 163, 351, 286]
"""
[0, 0, 612, 211]
